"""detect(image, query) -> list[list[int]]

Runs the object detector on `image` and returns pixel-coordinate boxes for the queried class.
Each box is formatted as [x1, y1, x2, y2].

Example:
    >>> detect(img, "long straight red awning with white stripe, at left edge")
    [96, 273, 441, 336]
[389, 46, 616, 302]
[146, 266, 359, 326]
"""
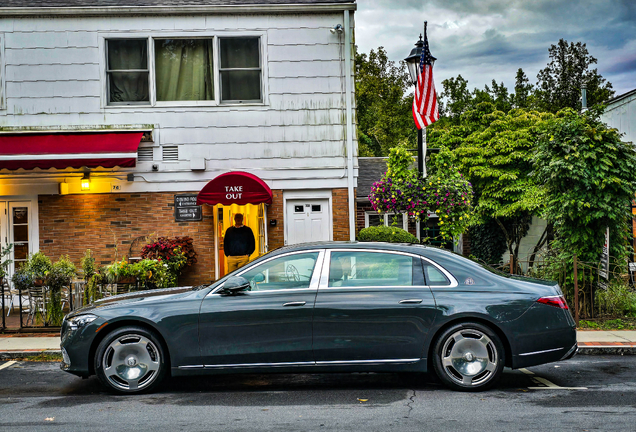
[0, 132, 143, 170]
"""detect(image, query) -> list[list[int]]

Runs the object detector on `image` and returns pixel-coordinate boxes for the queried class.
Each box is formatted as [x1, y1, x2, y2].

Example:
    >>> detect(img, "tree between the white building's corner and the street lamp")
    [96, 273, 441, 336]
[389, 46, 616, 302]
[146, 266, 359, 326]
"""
[355, 47, 417, 156]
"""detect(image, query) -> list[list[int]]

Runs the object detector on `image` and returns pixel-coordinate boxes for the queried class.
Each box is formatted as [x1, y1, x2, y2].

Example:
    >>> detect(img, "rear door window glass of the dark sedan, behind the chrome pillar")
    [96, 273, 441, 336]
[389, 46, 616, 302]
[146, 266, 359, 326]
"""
[329, 251, 413, 287]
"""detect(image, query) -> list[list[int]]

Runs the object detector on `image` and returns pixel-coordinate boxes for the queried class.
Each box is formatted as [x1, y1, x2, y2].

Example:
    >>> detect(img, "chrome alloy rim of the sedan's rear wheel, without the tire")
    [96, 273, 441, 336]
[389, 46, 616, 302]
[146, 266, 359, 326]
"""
[441, 329, 499, 386]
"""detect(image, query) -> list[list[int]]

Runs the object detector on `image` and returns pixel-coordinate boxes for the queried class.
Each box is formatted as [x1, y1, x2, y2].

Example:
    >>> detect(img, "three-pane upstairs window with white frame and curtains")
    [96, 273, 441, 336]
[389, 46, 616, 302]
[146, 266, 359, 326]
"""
[105, 36, 263, 105]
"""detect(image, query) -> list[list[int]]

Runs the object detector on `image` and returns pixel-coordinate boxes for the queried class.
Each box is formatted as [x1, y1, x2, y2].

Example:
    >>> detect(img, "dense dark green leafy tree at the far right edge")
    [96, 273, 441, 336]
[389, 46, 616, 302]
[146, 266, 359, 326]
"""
[535, 109, 636, 262]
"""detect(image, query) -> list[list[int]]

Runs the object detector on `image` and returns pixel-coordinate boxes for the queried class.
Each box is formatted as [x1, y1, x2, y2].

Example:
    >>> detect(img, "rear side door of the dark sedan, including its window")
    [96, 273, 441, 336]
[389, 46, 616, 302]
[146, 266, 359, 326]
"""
[314, 249, 436, 364]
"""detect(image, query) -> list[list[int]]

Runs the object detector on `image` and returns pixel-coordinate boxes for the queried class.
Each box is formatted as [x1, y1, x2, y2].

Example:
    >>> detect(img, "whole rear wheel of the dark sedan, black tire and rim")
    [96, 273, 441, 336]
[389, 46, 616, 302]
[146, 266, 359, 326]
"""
[433, 322, 505, 391]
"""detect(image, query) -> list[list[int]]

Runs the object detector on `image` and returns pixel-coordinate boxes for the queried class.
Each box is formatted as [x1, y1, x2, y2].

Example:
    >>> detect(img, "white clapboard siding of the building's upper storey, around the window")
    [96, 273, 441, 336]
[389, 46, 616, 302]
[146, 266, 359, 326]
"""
[0, 13, 357, 193]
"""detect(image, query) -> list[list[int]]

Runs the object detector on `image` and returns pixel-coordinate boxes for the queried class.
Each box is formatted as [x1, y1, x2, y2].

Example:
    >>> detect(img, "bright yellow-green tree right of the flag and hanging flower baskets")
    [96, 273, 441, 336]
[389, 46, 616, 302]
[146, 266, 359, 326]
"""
[431, 102, 550, 266]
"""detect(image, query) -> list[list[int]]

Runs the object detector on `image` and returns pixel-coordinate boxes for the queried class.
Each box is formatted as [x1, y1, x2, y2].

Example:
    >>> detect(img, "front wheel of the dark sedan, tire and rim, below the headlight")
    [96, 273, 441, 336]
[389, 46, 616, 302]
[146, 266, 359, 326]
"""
[95, 326, 167, 394]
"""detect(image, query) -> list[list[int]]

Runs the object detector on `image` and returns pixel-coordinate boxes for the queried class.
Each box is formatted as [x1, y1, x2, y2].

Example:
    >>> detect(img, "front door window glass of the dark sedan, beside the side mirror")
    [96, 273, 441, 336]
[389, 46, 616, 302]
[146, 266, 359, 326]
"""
[241, 252, 318, 291]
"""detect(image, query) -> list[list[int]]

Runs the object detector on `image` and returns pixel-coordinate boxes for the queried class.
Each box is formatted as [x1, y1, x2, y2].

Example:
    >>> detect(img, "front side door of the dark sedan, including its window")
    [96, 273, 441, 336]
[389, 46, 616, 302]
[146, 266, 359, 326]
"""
[199, 250, 324, 368]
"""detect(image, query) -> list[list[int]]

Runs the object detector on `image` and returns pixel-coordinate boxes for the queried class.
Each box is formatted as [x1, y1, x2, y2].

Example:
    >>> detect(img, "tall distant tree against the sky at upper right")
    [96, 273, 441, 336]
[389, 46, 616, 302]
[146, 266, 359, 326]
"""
[535, 39, 614, 112]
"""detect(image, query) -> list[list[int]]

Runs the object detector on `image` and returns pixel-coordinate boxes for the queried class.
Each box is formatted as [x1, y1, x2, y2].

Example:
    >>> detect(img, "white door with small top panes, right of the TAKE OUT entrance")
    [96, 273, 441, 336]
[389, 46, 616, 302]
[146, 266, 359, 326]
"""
[285, 199, 331, 245]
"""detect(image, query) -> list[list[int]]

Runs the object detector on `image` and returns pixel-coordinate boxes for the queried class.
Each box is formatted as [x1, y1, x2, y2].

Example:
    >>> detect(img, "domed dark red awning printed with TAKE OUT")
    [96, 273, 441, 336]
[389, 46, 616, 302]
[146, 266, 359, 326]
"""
[197, 171, 272, 205]
